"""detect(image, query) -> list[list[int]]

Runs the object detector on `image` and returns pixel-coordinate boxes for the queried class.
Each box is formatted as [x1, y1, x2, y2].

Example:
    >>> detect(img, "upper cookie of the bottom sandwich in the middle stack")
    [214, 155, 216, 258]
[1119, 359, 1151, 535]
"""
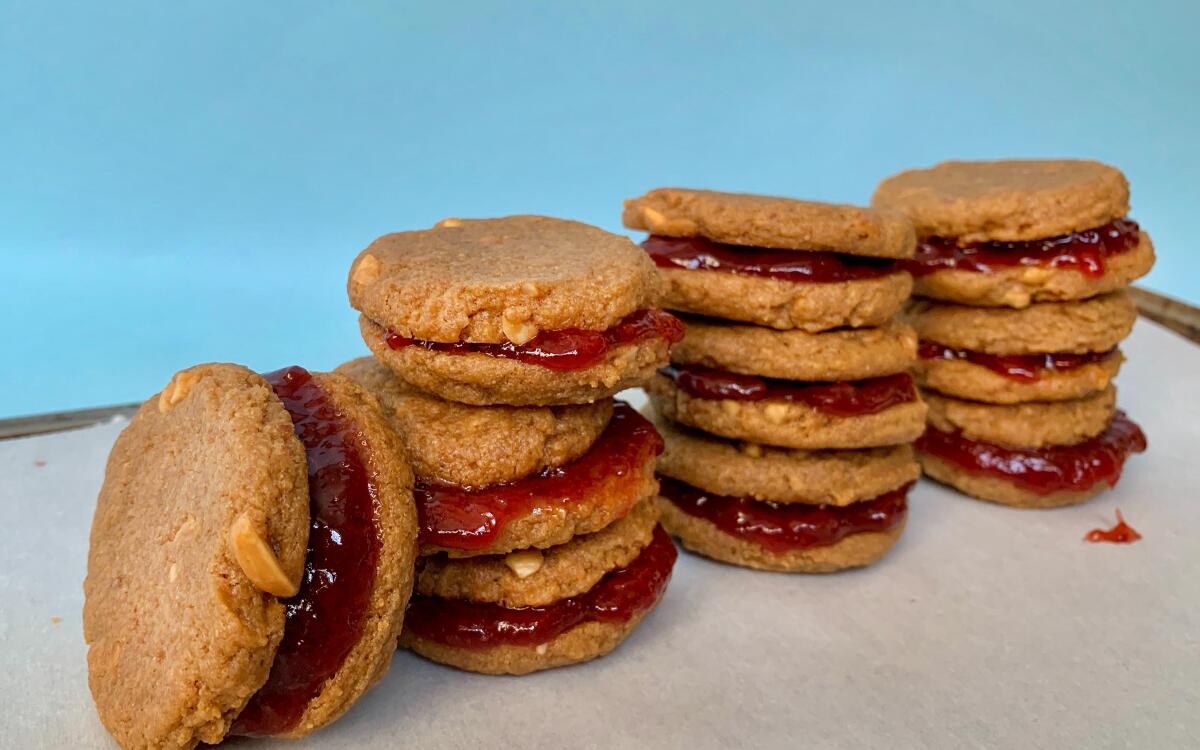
[652, 414, 920, 506]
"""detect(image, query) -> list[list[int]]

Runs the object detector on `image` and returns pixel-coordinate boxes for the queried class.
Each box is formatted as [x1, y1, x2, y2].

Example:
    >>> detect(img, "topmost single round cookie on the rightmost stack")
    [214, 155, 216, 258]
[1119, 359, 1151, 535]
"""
[871, 160, 1129, 242]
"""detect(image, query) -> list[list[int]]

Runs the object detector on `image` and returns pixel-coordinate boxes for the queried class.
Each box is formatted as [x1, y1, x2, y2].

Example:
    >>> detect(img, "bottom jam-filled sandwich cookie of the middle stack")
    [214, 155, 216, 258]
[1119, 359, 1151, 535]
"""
[653, 405, 920, 572]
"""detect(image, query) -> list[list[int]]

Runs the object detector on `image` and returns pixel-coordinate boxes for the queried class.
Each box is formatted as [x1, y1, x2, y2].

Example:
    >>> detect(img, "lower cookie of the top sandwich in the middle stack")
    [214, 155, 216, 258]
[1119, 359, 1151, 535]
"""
[659, 268, 912, 334]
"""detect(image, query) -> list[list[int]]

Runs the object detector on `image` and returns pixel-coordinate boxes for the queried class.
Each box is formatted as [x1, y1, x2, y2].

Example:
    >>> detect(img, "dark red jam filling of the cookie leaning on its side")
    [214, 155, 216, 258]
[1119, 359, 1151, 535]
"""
[232, 367, 380, 736]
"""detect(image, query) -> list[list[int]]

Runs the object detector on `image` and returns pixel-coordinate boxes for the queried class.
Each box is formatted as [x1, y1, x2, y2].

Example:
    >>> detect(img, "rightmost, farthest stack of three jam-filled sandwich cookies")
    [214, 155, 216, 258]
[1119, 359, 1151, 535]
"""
[874, 161, 1154, 508]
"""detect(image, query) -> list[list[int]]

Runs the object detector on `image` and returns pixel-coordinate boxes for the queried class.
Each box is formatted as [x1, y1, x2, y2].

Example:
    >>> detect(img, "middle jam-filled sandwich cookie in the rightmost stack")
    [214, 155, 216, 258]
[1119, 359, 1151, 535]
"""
[905, 290, 1138, 403]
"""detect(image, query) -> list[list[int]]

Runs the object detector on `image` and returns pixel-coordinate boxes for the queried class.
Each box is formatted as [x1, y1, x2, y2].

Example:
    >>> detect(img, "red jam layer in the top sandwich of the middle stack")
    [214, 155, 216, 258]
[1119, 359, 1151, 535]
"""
[642, 234, 896, 283]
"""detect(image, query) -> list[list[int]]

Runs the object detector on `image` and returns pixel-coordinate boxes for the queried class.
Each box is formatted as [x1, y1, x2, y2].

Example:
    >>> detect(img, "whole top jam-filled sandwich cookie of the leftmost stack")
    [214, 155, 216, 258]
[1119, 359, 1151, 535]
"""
[347, 216, 682, 406]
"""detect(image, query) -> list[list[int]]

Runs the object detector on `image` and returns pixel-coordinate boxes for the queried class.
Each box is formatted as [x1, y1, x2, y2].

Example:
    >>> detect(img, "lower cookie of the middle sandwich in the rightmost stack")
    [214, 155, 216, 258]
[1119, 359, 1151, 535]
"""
[913, 352, 1124, 403]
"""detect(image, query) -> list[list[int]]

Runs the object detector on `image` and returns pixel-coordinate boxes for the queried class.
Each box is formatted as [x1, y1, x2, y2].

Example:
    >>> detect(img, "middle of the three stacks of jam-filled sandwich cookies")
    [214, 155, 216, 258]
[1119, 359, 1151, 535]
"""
[624, 188, 925, 572]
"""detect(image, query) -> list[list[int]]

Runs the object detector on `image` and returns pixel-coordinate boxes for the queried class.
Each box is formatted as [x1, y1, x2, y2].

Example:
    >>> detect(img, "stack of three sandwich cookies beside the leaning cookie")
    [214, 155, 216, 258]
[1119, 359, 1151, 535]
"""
[338, 216, 683, 674]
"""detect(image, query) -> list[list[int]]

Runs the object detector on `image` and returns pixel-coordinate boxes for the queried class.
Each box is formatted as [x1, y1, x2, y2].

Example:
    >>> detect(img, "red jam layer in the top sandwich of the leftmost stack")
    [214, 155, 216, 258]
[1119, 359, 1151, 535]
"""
[384, 310, 683, 372]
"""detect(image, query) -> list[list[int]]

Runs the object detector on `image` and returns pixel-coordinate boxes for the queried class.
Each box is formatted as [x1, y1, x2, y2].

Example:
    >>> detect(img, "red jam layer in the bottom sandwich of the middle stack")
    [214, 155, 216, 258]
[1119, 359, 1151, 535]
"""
[659, 476, 912, 554]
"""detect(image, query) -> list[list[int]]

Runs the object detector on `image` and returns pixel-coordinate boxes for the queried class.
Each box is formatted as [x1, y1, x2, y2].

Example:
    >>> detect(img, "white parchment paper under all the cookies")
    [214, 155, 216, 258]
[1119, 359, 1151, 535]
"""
[0, 322, 1200, 750]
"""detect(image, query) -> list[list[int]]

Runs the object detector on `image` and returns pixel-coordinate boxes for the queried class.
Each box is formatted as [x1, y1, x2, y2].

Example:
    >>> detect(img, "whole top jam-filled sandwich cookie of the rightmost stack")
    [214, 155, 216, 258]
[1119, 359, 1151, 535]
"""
[872, 160, 1154, 307]
